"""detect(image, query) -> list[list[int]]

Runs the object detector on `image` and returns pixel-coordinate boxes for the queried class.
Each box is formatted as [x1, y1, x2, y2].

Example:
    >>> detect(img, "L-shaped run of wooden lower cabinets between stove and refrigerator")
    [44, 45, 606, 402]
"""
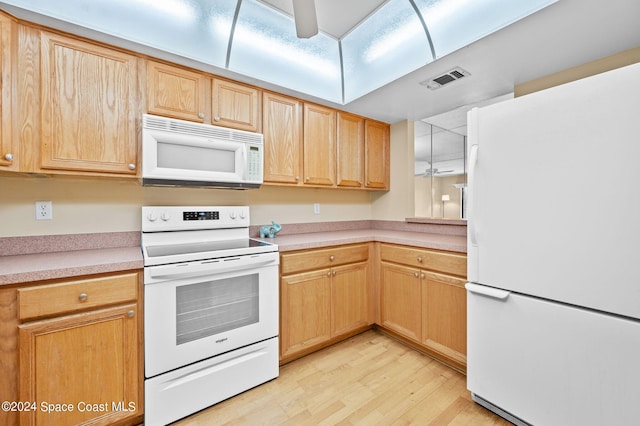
[280, 243, 467, 371]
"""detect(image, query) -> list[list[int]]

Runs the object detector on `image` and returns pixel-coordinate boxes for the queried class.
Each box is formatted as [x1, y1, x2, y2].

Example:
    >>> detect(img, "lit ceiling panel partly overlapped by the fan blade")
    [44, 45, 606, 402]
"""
[229, 0, 342, 102]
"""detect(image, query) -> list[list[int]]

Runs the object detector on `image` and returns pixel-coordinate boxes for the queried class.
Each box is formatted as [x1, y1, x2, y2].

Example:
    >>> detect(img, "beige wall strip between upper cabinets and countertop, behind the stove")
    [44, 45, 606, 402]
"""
[0, 177, 372, 237]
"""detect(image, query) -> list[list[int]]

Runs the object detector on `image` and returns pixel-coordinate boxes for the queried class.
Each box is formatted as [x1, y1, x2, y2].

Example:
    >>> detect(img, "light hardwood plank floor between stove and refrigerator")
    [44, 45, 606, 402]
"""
[176, 330, 511, 426]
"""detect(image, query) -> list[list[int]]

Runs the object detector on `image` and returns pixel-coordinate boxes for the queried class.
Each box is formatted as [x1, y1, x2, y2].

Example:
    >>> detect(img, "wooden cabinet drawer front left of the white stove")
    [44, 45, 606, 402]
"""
[18, 272, 138, 320]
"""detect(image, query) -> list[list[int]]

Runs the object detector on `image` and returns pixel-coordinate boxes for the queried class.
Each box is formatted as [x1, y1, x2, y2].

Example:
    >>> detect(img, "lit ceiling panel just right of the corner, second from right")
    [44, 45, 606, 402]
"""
[342, 0, 432, 103]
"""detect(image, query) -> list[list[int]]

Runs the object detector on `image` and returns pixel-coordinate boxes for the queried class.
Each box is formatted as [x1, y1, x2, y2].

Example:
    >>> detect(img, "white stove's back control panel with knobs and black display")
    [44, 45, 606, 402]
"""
[142, 206, 249, 232]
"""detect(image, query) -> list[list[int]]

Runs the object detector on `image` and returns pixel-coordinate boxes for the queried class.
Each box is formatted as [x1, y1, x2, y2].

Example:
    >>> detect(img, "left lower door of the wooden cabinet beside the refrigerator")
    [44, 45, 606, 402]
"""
[380, 262, 422, 342]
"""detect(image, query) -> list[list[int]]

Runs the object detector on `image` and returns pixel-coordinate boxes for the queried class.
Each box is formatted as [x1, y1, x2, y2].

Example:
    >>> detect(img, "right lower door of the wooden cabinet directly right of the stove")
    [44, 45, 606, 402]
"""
[331, 263, 369, 336]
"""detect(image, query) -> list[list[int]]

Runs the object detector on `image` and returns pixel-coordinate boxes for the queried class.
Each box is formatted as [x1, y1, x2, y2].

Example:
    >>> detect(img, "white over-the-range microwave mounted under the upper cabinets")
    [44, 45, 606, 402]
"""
[142, 114, 264, 189]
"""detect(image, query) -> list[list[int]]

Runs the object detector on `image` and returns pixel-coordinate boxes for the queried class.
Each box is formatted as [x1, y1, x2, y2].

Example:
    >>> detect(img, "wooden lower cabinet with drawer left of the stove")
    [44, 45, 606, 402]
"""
[0, 271, 143, 425]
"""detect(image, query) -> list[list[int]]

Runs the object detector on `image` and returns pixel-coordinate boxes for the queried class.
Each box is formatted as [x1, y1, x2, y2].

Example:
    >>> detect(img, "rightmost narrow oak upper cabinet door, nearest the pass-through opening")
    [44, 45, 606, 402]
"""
[364, 120, 391, 189]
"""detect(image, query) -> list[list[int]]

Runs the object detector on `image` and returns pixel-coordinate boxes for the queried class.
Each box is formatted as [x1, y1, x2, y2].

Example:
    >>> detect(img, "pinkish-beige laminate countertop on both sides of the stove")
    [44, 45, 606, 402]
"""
[0, 222, 467, 286]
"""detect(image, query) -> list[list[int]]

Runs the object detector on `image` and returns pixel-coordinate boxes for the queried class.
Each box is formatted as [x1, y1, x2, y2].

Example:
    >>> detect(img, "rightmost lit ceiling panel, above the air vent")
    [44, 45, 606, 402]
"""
[414, 0, 557, 58]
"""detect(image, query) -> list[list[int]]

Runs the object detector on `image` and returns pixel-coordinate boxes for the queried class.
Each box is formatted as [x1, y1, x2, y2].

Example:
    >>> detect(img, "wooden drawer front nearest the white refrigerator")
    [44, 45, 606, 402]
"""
[380, 244, 467, 277]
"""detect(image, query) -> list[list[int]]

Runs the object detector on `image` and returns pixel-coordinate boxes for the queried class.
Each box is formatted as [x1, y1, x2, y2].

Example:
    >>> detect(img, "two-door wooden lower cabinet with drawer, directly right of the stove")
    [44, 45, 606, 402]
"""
[280, 244, 372, 363]
